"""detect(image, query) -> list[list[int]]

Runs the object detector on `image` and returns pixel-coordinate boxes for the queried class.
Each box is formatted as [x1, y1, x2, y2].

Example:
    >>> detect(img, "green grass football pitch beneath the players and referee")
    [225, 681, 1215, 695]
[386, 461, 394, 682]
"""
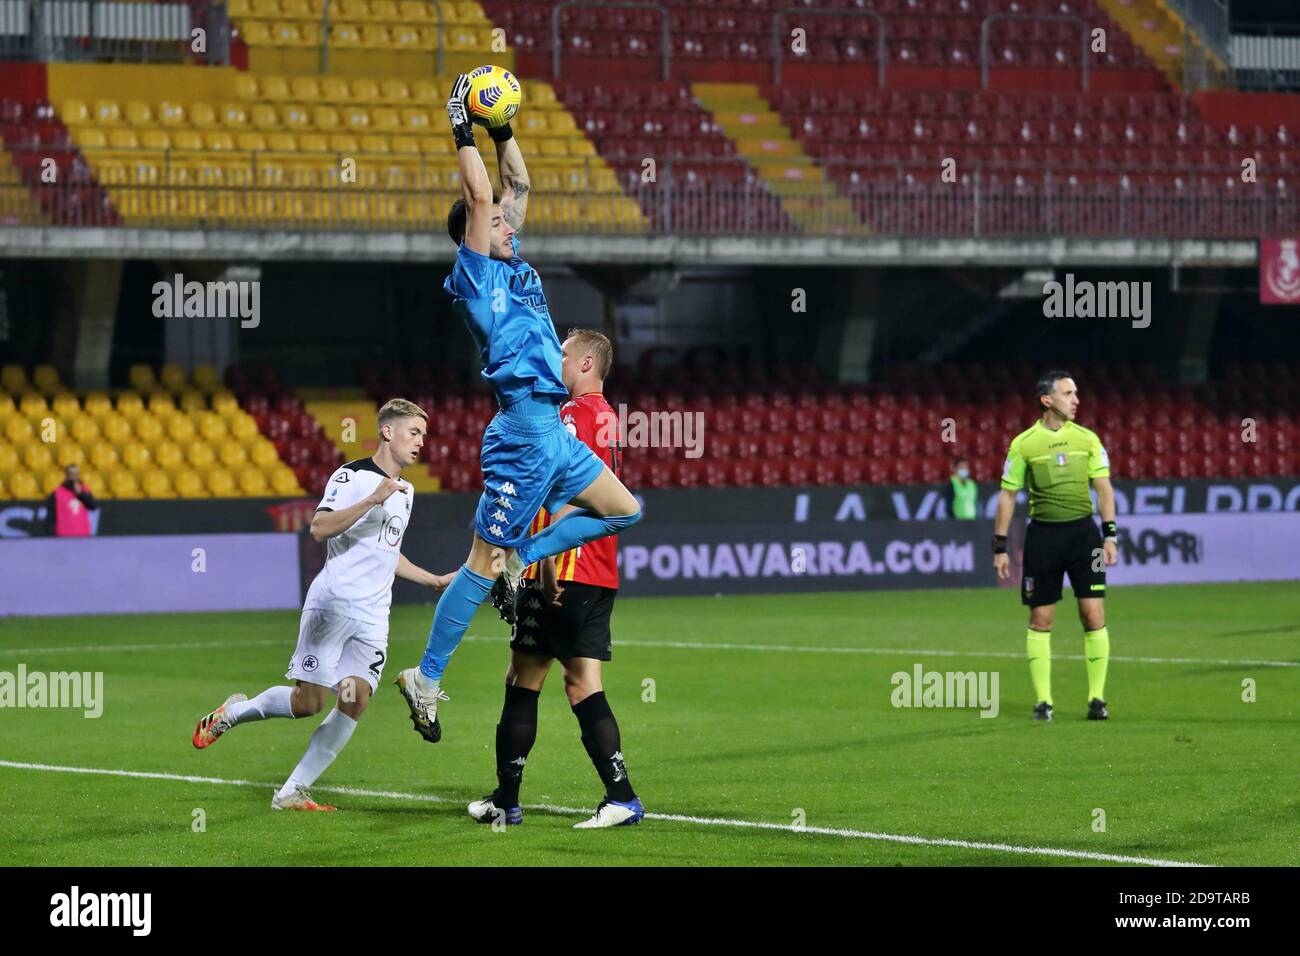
[0, 583, 1300, 866]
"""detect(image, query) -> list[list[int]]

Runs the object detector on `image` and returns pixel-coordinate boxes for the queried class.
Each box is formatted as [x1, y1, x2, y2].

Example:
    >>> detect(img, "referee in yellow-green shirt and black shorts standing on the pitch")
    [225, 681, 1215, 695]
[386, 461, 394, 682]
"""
[993, 372, 1118, 721]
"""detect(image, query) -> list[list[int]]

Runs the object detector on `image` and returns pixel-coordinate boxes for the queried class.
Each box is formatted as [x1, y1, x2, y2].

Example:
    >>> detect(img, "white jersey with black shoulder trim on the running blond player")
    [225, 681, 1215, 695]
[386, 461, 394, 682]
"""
[303, 458, 413, 624]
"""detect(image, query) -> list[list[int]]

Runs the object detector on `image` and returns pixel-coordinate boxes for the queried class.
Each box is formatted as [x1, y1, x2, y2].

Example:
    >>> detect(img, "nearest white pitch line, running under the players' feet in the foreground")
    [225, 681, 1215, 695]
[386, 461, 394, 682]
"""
[0, 760, 1208, 866]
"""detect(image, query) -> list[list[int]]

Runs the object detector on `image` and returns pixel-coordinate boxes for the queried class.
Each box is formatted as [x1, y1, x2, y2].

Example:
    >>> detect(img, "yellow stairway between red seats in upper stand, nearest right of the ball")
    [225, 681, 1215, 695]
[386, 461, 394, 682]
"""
[690, 83, 867, 235]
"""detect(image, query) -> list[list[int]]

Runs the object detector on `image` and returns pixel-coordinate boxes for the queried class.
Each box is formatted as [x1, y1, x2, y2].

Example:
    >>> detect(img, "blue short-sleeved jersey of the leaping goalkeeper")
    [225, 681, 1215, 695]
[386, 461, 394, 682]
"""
[442, 237, 568, 407]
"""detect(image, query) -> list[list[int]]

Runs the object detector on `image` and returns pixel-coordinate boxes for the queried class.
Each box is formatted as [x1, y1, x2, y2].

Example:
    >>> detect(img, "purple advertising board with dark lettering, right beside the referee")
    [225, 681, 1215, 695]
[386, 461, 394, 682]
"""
[1106, 511, 1300, 585]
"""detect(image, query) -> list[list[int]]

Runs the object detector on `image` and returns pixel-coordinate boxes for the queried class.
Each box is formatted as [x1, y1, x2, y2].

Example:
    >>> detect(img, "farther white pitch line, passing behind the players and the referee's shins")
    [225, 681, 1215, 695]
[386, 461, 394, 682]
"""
[0, 635, 1300, 667]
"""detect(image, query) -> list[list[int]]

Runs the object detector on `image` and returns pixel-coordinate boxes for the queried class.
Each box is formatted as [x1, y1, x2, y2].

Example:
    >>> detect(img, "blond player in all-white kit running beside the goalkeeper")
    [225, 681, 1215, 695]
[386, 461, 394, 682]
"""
[194, 398, 452, 810]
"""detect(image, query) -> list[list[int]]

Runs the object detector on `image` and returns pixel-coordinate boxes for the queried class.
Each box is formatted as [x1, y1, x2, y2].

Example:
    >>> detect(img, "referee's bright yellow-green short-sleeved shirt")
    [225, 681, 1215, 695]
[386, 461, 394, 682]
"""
[1002, 420, 1110, 522]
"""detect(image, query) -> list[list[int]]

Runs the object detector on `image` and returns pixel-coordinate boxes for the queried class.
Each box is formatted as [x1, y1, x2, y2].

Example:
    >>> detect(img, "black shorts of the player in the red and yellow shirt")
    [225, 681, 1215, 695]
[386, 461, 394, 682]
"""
[510, 581, 619, 661]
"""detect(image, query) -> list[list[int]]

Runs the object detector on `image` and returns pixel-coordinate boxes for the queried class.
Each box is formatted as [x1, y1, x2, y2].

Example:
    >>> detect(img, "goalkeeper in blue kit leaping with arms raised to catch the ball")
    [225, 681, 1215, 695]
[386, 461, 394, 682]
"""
[397, 75, 641, 743]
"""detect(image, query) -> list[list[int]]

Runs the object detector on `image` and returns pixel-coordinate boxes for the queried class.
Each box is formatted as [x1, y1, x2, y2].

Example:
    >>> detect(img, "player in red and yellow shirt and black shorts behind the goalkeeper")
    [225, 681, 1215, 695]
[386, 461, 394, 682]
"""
[469, 329, 645, 829]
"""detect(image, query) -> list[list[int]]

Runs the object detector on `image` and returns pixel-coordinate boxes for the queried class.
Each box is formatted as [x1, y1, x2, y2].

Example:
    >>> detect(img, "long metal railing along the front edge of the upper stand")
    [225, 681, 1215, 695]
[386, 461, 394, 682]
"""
[0, 150, 1300, 238]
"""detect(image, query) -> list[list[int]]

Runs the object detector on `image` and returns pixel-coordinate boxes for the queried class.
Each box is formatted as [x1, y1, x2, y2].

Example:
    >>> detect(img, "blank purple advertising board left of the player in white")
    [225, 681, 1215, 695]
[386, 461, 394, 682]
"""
[0, 533, 302, 617]
